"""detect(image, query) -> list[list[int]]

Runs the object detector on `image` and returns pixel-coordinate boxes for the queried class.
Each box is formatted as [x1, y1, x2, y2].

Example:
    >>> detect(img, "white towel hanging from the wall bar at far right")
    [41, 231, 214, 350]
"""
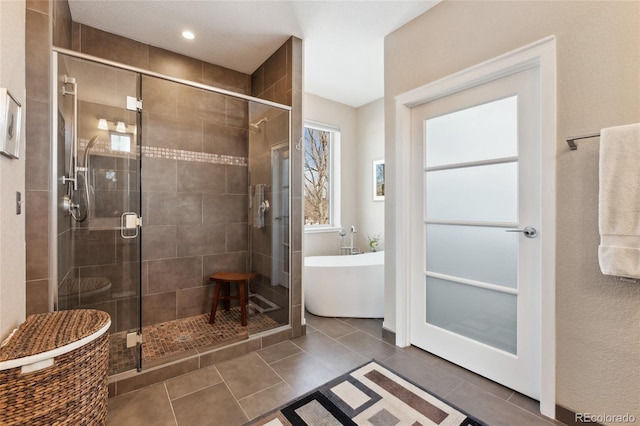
[598, 123, 640, 278]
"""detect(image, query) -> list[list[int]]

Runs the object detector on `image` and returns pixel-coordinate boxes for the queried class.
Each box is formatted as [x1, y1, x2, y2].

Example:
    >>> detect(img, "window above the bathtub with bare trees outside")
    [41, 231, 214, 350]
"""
[304, 123, 340, 230]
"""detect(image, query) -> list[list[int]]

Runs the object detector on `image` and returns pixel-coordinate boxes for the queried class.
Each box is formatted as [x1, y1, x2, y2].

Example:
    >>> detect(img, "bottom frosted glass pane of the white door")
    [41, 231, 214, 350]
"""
[426, 277, 517, 354]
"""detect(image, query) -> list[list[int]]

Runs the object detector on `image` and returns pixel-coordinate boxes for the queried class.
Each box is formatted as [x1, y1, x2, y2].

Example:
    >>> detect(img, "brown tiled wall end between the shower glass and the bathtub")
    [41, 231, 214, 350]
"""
[251, 37, 304, 337]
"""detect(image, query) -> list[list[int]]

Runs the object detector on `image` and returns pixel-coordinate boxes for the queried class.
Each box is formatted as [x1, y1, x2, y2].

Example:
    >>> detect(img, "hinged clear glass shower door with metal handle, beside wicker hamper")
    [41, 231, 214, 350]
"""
[56, 54, 141, 374]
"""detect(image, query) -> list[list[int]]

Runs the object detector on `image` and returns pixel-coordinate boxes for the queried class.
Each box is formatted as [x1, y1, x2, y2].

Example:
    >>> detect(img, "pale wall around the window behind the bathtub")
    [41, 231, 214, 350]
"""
[303, 93, 384, 256]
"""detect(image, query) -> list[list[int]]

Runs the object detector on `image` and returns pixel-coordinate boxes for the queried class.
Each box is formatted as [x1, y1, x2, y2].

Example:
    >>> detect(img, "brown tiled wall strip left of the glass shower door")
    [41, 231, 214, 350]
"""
[25, 0, 71, 315]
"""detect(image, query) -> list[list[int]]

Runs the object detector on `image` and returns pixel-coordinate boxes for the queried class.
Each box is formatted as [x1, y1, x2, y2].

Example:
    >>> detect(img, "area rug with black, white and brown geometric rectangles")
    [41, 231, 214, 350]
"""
[247, 361, 483, 426]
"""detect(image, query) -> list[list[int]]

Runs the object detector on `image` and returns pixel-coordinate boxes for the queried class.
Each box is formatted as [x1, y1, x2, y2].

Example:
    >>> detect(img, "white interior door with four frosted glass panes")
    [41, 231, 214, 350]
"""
[410, 68, 544, 399]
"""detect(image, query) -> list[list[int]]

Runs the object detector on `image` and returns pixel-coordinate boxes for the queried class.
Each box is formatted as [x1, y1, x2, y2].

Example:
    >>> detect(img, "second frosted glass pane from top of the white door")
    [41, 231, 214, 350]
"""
[425, 162, 518, 222]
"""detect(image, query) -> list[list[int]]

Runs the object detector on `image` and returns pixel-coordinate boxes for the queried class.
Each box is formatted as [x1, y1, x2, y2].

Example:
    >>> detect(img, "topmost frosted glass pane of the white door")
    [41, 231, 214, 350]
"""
[425, 96, 518, 167]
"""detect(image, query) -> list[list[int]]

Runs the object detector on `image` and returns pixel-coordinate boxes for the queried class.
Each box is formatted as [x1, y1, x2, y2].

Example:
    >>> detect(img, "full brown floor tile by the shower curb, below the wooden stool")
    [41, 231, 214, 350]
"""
[216, 353, 282, 399]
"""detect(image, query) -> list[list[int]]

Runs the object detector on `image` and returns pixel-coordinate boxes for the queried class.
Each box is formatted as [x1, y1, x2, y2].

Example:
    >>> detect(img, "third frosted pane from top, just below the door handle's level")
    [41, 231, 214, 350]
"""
[426, 225, 519, 288]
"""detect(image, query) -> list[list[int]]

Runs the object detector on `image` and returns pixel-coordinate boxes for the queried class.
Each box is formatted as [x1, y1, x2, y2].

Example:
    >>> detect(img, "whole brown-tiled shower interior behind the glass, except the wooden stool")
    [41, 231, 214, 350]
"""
[52, 53, 290, 375]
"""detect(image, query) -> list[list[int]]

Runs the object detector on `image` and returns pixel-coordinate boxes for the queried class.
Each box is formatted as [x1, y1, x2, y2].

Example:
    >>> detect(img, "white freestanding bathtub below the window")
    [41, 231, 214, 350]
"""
[304, 251, 384, 318]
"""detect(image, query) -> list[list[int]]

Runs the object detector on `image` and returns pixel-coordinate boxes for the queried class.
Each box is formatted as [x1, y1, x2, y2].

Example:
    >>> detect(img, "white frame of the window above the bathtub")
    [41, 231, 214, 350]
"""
[303, 120, 341, 234]
